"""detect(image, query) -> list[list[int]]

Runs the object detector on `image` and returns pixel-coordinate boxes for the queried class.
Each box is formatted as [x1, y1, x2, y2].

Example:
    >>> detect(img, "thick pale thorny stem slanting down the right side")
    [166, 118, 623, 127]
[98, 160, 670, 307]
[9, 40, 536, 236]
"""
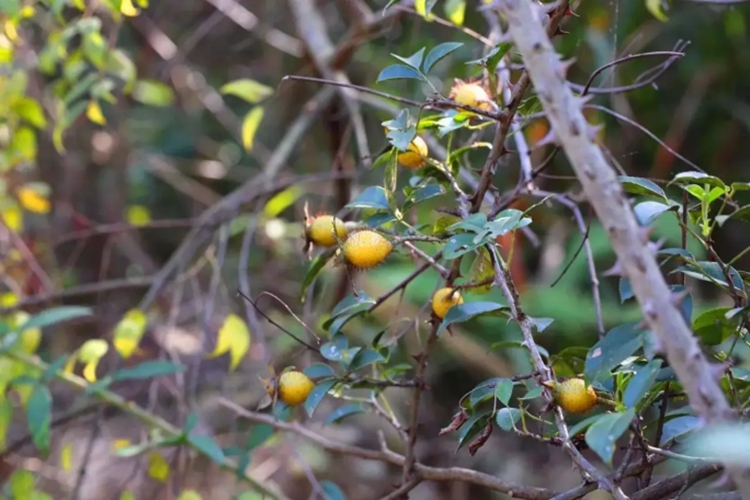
[499, 0, 750, 491]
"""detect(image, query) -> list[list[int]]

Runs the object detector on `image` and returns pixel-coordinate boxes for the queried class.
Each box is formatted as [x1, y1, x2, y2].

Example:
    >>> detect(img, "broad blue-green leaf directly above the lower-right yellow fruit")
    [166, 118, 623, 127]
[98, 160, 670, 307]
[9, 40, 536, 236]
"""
[584, 323, 645, 381]
